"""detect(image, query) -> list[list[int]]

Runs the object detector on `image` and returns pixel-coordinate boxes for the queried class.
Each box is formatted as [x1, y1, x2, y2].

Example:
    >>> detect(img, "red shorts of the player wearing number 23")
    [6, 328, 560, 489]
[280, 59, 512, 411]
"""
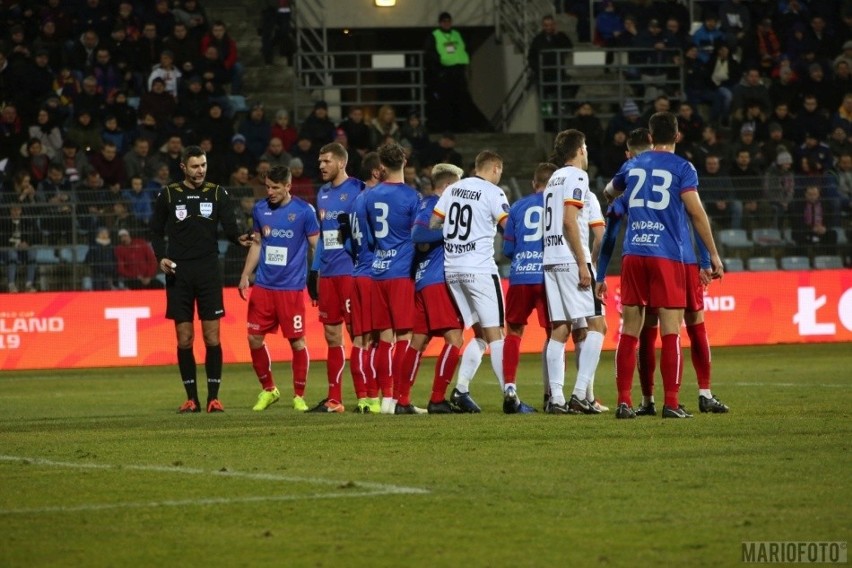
[621, 255, 686, 309]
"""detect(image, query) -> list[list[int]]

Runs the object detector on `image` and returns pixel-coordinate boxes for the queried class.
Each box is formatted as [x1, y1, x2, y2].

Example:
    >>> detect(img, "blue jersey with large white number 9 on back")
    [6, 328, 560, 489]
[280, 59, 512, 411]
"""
[503, 192, 544, 285]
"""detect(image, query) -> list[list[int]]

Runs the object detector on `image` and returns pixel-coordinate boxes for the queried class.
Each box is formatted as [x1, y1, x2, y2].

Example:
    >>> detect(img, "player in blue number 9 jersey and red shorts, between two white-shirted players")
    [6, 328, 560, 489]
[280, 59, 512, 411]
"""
[503, 162, 557, 404]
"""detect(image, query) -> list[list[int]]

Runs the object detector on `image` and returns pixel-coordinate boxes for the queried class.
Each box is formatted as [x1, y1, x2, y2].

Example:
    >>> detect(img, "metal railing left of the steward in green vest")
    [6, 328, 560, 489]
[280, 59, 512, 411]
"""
[295, 51, 426, 121]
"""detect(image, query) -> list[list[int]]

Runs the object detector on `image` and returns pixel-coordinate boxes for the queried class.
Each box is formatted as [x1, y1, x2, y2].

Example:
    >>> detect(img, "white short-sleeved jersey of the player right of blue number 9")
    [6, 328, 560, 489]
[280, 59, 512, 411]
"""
[541, 162, 589, 265]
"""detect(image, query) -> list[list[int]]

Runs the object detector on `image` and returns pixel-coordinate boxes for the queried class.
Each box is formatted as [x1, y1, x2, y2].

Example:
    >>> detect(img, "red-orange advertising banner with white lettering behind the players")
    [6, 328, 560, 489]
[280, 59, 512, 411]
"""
[0, 270, 852, 370]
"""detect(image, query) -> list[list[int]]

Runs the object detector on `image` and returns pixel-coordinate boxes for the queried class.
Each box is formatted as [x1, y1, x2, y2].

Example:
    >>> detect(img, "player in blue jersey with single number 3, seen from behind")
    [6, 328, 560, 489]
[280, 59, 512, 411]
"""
[365, 142, 420, 414]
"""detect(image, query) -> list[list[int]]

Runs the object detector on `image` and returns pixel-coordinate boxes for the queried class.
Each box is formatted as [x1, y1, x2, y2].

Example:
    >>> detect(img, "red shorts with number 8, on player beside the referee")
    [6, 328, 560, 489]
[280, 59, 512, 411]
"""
[246, 286, 305, 339]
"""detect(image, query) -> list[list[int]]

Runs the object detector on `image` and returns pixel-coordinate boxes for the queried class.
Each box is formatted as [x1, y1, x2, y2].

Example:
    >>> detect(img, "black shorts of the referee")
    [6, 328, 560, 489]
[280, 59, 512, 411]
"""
[166, 256, 225, 323]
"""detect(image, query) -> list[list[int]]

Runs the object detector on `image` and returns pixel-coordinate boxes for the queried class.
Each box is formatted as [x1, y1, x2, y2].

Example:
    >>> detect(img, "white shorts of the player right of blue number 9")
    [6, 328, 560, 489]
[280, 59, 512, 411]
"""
[544, 264, 603, 327]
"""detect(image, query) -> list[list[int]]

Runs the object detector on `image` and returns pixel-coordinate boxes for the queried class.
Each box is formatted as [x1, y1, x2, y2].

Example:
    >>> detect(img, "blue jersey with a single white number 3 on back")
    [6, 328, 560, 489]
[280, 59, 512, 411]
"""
[366, 182, 420, 280]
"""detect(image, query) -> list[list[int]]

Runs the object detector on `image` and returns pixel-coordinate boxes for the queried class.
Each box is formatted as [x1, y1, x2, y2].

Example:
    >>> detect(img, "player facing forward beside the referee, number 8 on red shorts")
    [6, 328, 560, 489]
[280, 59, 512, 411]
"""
[239, 166, 319, 411]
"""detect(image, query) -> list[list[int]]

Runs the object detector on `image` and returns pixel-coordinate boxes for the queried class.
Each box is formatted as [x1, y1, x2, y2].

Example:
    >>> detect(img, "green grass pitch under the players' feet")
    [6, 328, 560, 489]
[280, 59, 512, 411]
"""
[0, 344, 852, 567]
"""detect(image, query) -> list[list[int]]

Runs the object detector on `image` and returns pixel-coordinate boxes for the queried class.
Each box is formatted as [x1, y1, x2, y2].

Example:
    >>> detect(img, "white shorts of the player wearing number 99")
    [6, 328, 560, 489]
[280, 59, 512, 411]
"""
[445, 272, 504, 329]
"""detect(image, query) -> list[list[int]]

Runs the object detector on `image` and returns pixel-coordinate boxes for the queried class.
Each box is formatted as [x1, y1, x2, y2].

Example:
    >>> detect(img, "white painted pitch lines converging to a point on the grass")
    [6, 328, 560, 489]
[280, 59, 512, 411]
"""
[0, 455, 429, 515]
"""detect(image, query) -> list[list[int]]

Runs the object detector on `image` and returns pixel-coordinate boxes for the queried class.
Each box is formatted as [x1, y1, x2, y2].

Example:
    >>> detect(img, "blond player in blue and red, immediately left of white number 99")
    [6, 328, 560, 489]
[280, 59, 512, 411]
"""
[397, 164, 464, 414]
